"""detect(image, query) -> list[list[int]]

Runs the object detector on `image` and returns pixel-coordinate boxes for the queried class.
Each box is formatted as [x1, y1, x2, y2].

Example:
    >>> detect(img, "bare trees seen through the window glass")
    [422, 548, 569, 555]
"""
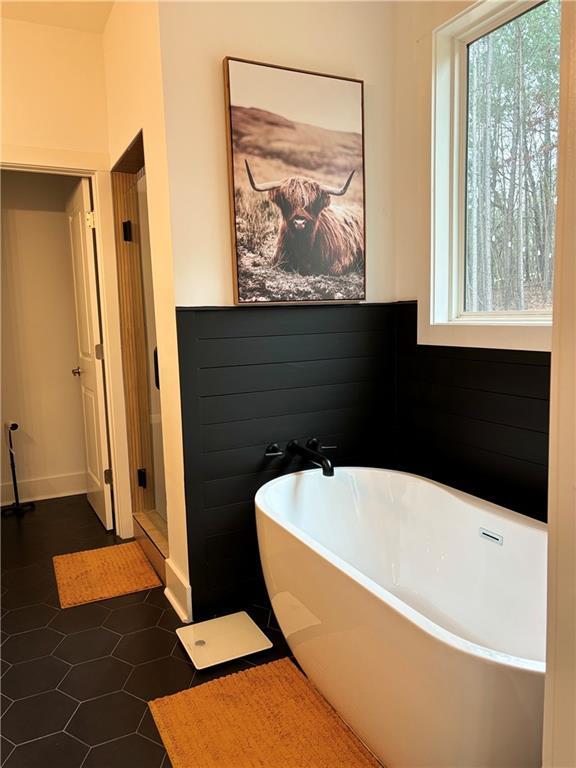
[464, 0, 560, 312]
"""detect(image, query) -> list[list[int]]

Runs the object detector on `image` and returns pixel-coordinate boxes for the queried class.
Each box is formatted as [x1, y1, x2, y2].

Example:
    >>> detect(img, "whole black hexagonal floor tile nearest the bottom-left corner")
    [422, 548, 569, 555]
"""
[2, 691, 78, 744]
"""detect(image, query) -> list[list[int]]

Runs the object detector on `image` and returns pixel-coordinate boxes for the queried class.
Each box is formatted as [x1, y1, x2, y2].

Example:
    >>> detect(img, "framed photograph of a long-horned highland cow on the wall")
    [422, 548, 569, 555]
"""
[224, 58, 366, 304]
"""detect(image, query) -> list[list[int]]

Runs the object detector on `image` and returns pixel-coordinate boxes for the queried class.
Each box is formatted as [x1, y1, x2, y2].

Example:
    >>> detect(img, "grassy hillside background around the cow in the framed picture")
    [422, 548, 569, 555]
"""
[231, 106, 364, 302]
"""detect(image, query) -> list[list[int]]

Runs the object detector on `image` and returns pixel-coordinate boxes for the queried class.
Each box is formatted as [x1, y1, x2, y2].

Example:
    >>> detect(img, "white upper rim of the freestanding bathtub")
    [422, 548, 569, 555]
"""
[254, 466, 547, 674]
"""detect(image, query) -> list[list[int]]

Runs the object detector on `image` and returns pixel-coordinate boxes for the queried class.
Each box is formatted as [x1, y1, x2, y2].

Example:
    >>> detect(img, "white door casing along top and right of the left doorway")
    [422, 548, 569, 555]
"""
[0, 162, 134, 539]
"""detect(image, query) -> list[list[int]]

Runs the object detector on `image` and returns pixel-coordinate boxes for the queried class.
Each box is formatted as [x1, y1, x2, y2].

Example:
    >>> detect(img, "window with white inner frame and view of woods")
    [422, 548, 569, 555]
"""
[432, 0, 560, 324]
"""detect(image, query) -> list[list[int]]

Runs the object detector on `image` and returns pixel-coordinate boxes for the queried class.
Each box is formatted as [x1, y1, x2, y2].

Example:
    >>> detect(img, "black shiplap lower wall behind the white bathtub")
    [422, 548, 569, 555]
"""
[177, 303, 550, 620]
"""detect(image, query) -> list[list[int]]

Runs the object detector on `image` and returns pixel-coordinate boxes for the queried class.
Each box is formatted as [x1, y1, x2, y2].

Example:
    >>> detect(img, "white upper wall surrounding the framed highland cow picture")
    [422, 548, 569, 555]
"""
[160, 2, 396, 306]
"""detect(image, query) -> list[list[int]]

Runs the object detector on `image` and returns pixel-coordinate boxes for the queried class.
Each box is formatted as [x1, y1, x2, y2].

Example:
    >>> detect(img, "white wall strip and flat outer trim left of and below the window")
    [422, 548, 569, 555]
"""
[392, 0, 551, 350]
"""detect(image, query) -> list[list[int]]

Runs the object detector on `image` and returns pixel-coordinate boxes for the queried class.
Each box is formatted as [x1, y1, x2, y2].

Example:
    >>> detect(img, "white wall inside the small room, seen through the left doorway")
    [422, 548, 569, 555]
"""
[0, 172, 86, 502]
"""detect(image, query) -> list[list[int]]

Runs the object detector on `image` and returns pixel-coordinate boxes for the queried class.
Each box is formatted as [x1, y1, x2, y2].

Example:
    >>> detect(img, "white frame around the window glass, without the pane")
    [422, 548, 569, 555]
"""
[430, 0, 552, 332]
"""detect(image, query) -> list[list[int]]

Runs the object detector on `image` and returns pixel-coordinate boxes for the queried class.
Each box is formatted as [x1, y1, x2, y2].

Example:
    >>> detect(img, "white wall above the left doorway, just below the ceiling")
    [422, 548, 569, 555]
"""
[1, 19, 108, 169]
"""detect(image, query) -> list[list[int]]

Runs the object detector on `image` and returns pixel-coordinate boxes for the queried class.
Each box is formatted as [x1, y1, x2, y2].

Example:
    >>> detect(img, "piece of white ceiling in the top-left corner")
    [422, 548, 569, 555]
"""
[2, 0, 114, 32]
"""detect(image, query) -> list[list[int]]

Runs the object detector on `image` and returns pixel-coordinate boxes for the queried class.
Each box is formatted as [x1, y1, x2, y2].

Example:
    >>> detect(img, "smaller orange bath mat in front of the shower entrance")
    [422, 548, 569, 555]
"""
[52, 541, 162, 608]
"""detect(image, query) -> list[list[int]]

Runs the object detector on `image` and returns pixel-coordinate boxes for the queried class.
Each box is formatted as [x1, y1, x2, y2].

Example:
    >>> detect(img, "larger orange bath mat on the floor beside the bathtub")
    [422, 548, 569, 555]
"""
[149, 659, 380, 768]
